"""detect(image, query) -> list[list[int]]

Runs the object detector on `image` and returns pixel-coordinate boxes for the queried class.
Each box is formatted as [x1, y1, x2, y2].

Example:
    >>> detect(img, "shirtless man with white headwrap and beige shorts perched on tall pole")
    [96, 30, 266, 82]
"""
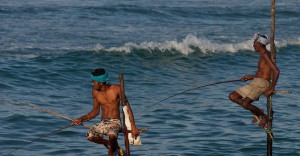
[229, 33, 280, 127]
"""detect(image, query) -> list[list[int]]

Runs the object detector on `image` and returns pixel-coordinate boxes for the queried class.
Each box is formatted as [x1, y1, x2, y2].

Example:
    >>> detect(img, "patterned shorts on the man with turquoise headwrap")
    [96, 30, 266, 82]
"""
[86, 119, 121, 138]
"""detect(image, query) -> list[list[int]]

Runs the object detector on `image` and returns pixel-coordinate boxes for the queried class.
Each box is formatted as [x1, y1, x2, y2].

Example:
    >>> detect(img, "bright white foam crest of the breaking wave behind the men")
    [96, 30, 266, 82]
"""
[93, 35, 300, 55]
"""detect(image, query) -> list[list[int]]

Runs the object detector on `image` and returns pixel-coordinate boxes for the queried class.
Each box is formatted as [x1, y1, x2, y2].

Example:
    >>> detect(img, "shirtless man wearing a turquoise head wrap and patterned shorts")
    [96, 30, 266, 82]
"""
[72, 68, 139, 156]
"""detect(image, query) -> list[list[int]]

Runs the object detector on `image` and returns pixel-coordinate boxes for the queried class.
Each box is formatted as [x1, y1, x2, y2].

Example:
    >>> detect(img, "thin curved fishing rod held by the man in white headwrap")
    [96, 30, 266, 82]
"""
[137, 79, 242, 115]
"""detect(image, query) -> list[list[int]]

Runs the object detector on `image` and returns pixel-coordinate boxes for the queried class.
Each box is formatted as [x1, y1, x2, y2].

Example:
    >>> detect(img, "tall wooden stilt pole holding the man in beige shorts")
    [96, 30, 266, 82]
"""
[267, 0, 276, 156]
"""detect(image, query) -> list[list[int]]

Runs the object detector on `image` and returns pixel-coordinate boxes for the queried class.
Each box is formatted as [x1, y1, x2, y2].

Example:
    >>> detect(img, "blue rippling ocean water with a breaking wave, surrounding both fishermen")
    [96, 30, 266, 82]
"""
[0, 0, 300, 156]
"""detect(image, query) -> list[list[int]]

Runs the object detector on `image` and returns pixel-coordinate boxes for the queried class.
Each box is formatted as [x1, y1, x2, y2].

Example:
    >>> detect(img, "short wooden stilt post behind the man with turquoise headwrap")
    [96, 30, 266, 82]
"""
[119, 74, 130, 156]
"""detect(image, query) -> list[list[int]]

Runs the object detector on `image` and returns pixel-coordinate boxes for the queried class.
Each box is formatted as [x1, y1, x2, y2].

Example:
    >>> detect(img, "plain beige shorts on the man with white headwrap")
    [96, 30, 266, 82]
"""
[235, 78, 270, 101]
